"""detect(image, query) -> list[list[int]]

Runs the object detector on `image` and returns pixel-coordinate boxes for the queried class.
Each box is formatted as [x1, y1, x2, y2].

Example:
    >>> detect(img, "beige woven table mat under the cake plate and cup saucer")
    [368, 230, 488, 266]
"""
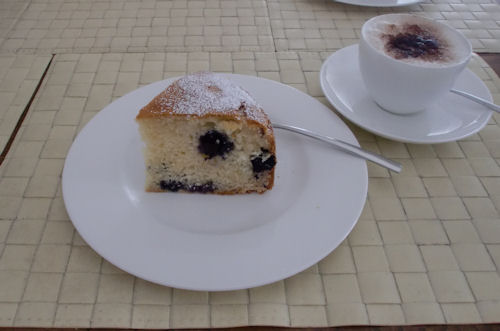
[0, 51, 500, 328]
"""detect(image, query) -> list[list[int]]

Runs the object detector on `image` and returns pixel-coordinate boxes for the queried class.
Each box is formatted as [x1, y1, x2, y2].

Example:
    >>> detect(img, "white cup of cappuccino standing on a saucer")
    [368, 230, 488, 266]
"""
[359, 14, 472, 114]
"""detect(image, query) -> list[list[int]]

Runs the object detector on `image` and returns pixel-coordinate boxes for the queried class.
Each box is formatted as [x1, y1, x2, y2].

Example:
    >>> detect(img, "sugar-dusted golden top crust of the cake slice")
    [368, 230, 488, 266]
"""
[157, 72, 268, 124]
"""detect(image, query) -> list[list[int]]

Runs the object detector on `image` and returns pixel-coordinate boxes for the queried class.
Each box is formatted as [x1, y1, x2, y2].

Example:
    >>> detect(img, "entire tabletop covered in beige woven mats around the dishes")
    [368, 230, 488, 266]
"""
[0, 0, 500, 328]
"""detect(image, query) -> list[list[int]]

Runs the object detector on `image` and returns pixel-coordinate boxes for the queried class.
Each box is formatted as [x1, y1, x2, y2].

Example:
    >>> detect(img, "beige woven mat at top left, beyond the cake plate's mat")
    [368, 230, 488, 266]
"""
[1, 0, 274, 53]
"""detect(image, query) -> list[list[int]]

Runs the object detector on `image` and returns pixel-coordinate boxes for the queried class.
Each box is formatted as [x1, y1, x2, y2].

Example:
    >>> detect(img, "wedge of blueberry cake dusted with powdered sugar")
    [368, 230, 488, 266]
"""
[136, 72, 276, 194]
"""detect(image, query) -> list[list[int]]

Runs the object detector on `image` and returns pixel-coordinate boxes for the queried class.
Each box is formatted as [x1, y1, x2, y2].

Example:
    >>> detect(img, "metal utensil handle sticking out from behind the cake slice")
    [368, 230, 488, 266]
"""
[273, 123, 402, 173]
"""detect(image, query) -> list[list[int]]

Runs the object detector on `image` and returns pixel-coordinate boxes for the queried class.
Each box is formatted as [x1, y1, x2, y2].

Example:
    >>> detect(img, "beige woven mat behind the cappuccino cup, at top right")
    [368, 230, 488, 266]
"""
[268, 0, 500, 52]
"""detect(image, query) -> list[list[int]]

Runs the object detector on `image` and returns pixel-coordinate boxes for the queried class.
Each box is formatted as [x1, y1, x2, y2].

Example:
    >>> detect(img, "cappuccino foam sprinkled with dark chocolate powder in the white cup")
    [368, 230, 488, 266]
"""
[364, 15, 469, 67]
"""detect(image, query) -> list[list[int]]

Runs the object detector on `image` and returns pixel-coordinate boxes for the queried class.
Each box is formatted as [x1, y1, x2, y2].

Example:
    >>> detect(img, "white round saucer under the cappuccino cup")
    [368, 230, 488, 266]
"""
[320, 45, 492, 144]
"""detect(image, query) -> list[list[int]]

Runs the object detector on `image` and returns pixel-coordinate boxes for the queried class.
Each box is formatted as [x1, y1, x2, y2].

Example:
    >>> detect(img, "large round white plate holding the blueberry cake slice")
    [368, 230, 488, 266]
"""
[62, 75, 368, 291]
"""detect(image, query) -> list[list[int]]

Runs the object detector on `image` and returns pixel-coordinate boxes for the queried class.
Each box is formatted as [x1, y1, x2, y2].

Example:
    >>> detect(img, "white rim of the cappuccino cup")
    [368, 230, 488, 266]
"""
[361, 13, 473, 70]
